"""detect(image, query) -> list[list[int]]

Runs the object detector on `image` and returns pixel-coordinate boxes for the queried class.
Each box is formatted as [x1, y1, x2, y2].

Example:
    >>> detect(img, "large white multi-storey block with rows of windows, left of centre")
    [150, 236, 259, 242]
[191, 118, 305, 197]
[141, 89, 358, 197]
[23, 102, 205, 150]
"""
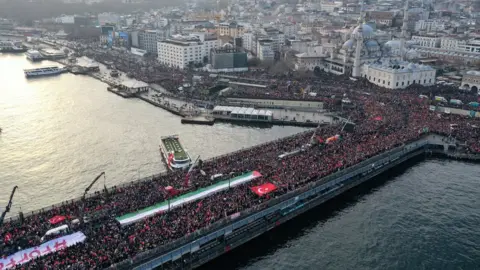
[157, 35, 220, 69]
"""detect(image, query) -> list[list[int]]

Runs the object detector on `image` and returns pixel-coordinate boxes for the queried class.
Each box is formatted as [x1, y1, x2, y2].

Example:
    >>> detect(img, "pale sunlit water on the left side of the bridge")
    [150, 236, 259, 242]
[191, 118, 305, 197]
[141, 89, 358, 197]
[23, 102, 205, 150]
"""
[0, 55, 303, 214]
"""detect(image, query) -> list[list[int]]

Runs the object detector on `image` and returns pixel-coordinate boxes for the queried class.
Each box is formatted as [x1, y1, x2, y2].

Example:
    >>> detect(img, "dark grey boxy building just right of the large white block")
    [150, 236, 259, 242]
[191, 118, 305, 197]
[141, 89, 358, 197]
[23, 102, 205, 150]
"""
[210, 44, 248, 72]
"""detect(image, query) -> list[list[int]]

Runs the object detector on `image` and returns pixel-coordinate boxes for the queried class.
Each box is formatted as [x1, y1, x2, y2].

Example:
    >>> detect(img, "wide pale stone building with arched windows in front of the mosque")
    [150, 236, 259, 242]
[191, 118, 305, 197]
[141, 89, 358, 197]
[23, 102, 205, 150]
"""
[362, 61, 436, 89]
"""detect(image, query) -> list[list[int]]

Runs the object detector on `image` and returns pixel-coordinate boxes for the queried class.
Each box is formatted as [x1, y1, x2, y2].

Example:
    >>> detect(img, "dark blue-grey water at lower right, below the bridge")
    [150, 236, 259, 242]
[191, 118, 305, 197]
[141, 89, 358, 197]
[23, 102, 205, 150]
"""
[202, 160, 480, 270]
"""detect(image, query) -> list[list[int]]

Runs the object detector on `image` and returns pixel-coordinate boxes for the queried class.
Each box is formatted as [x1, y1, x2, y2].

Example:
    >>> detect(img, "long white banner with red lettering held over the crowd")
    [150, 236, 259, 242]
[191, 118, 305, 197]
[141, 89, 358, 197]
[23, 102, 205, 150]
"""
[0, 232, 86, 270]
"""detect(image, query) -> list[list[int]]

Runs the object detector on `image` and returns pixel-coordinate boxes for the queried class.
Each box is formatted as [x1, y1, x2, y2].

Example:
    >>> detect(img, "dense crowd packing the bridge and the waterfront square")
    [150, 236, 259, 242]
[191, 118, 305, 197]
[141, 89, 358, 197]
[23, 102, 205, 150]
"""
[0, 61, 480, 269]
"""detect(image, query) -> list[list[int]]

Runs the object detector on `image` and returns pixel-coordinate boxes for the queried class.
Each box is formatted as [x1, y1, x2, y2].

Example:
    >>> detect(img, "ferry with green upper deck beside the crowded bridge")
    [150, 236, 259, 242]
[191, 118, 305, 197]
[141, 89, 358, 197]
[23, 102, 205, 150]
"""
[160, 135, 192, 170]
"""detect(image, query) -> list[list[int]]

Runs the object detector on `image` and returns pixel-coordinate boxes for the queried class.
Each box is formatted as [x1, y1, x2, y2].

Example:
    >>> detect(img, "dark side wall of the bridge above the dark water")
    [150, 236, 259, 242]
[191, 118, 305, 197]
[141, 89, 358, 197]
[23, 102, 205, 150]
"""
[120, 139, 430, 270]
